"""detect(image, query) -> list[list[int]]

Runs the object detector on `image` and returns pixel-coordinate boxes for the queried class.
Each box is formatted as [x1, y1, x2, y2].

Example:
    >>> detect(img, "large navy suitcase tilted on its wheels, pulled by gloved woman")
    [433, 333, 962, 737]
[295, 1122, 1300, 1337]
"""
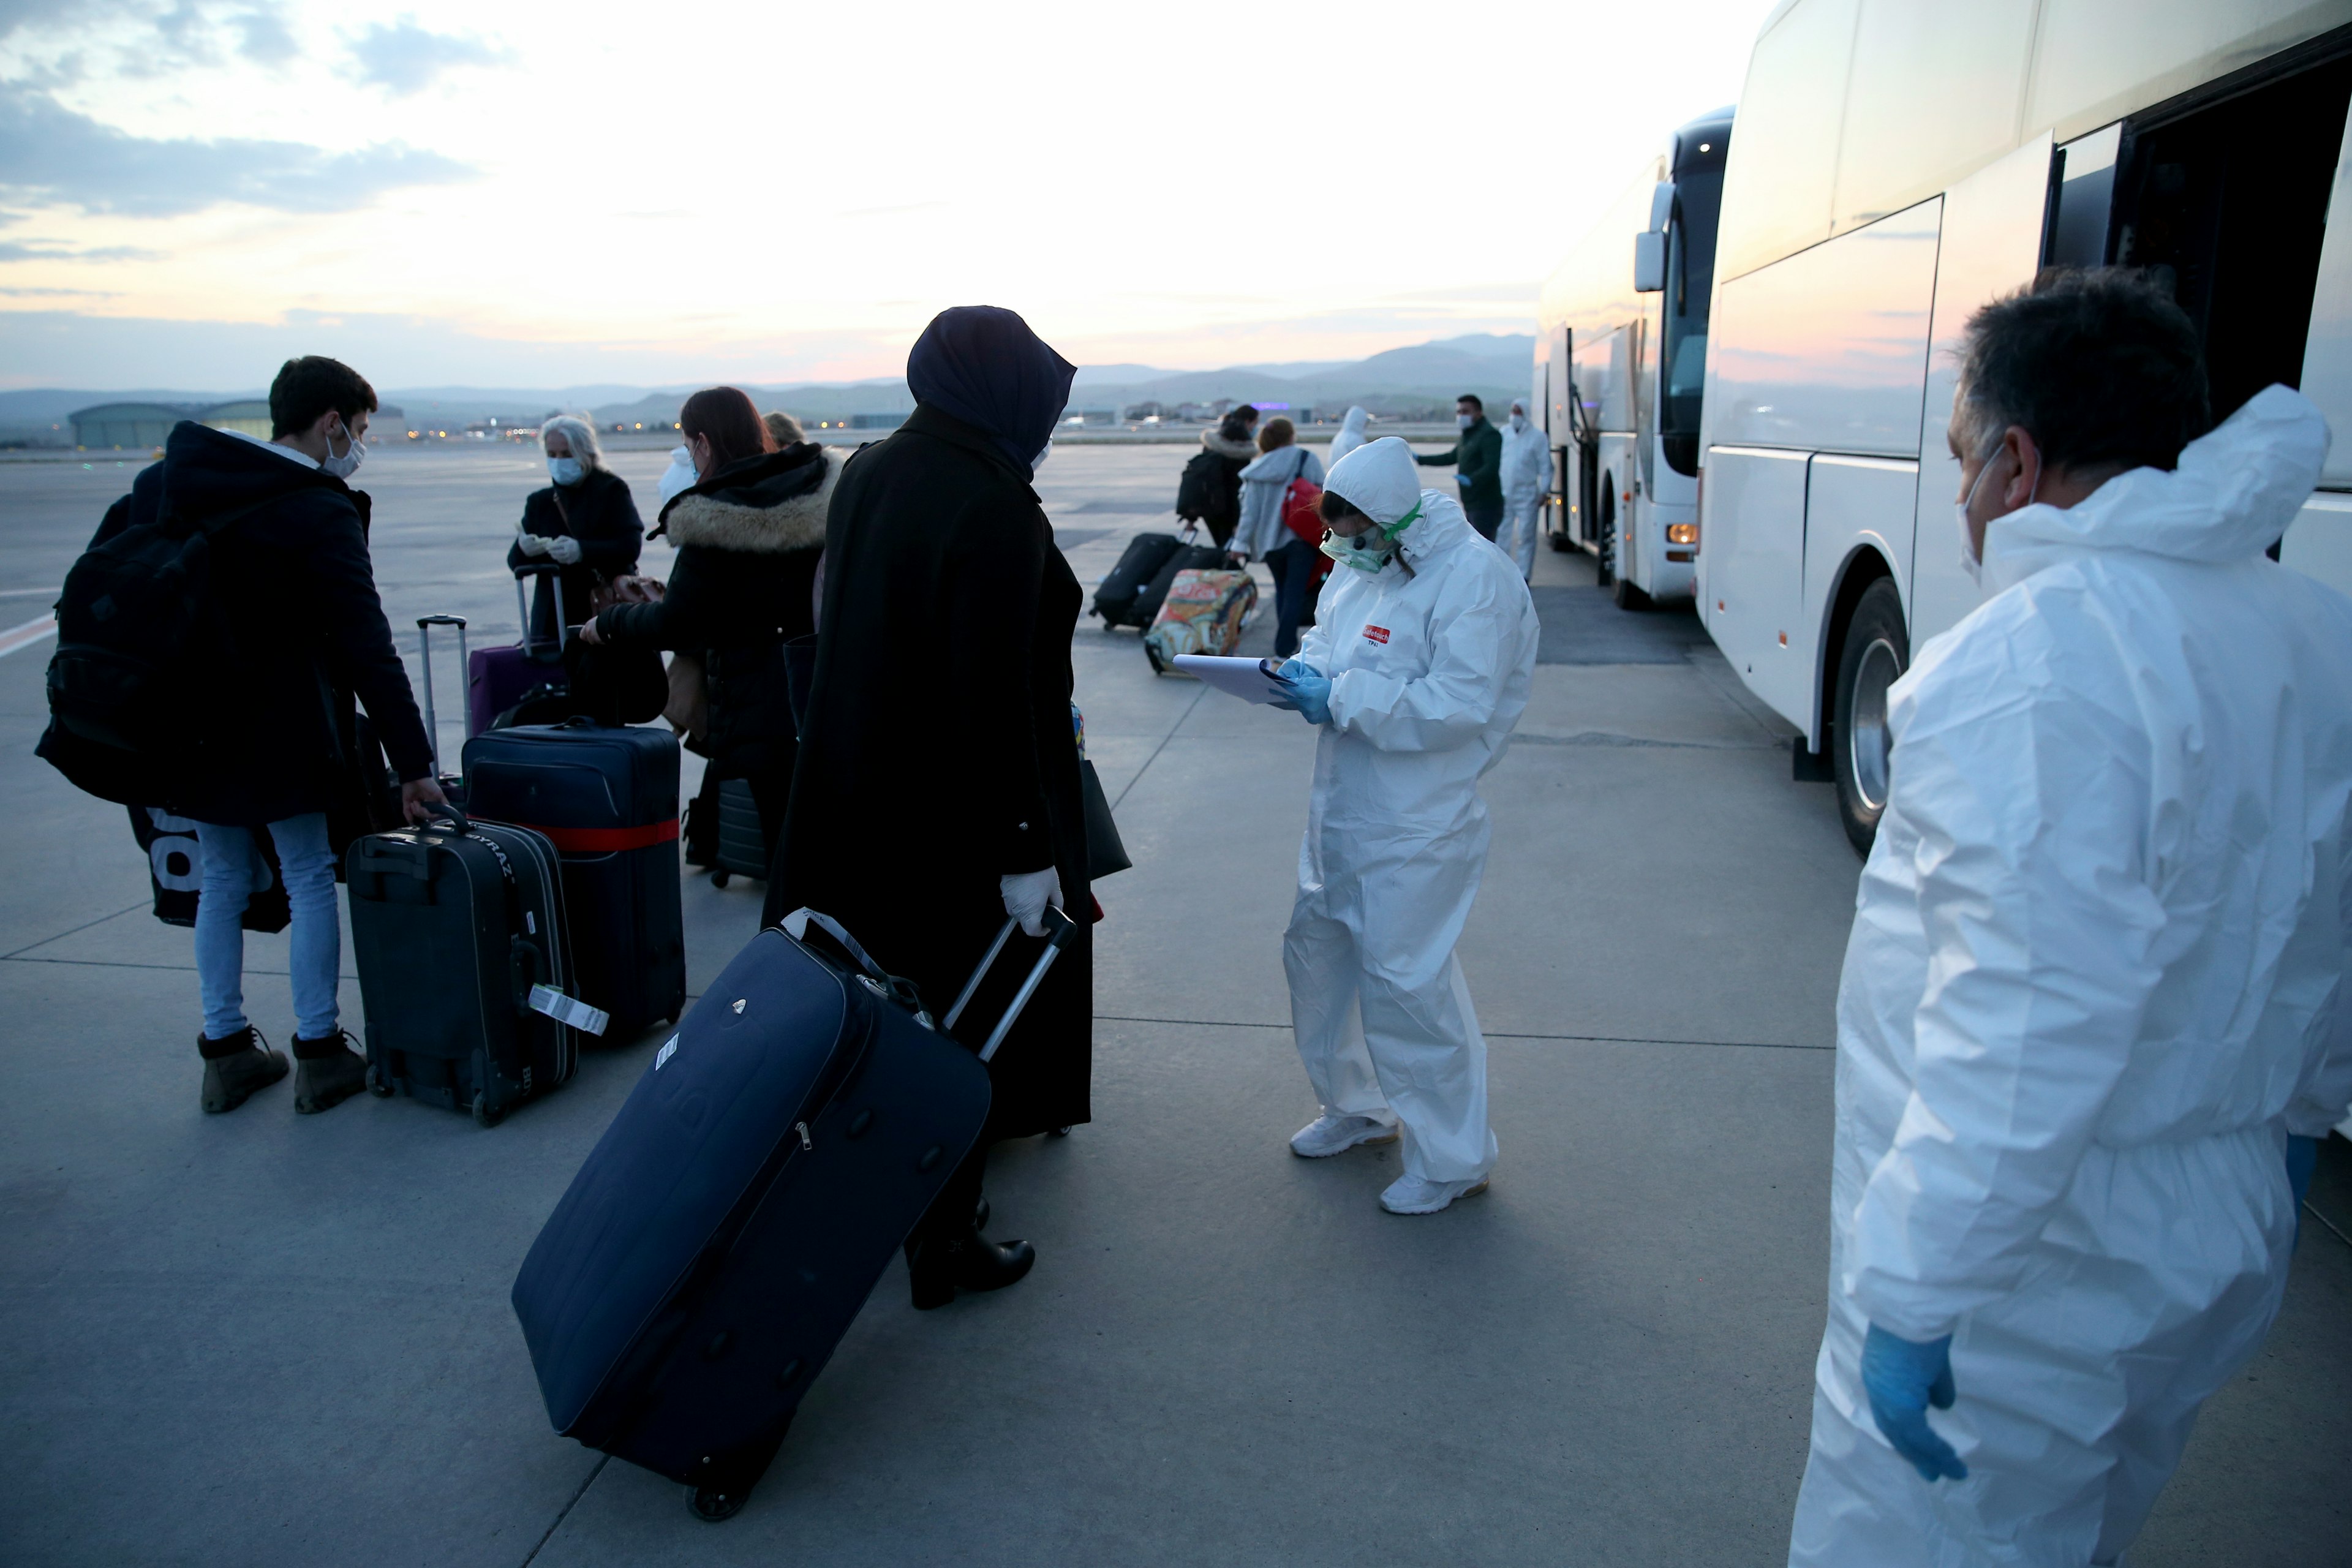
[513, 910, 1075, 1518]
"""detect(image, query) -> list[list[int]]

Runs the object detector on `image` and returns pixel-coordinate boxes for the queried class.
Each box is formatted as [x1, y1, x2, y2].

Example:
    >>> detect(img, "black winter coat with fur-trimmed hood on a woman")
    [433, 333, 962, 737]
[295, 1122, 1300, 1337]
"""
[597, 442, 842, 778]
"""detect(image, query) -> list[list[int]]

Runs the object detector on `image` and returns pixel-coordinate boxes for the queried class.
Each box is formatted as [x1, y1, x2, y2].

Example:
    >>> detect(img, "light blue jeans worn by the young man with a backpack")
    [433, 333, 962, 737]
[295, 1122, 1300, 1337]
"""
[195, 811, 344, 1039]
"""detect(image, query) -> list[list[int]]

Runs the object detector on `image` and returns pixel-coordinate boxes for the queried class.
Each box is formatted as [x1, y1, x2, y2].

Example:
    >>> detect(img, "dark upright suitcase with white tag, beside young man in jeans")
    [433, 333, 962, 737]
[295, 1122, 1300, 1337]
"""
[344, 811, 605, 1126]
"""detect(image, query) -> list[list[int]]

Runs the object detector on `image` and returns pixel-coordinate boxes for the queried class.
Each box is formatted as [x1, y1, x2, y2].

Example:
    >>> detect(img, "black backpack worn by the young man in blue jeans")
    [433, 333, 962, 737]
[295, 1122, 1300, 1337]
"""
[42, 496, 263, 780]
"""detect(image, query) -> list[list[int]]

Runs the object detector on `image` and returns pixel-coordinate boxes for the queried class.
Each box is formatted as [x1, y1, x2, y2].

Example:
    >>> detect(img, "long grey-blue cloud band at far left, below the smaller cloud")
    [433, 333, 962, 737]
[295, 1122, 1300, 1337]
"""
[0, 82, 473, 219]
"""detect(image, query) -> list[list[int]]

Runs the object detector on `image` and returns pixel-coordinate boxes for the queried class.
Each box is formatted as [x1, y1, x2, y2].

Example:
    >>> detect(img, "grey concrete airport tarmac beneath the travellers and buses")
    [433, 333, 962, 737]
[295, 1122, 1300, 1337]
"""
[0, 444, 2352, 1568]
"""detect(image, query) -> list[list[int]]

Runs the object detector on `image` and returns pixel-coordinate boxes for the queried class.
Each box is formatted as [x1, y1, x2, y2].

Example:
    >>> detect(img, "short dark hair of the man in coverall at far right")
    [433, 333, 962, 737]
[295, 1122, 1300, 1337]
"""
[1959, 268, 2213, 468]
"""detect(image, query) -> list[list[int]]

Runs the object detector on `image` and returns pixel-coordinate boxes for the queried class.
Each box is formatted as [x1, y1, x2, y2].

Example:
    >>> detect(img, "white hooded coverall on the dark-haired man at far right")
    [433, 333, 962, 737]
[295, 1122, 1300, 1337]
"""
[1787, 388, 2352, 1568]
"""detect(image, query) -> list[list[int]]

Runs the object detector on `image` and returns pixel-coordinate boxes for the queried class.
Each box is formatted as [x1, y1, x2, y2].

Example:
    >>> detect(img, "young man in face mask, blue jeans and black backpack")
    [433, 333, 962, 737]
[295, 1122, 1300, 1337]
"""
[40, 355, 445, 1112]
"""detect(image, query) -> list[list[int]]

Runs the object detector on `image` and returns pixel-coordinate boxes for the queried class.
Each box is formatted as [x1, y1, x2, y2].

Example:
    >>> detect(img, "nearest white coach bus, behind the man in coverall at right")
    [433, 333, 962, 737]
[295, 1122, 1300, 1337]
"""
[1698, 0, 2352, 849]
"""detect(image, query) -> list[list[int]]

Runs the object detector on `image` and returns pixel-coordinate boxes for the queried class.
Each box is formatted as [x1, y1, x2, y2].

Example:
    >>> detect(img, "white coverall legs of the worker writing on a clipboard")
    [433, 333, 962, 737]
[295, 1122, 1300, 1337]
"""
[1282, 813, 1496, 1183]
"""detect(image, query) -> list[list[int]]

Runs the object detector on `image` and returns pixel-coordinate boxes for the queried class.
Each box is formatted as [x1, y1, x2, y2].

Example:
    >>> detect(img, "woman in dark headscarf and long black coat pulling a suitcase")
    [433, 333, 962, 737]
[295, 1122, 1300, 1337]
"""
[767, 306, 1094, 1307]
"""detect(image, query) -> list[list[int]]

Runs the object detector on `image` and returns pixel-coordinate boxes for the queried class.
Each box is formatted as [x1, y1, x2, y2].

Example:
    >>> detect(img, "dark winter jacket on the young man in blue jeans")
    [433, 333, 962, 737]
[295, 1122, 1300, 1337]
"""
[89, 423, 433, 825]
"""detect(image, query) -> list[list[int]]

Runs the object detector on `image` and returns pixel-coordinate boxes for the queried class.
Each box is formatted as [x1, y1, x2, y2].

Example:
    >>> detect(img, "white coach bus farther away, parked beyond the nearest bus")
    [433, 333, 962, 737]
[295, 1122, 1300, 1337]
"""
[1529, 108, 1731, 609]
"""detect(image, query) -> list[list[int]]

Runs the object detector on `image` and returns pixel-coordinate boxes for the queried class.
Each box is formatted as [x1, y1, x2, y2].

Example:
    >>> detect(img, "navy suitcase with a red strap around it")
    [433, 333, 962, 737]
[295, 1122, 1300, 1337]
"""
[466, 719, 687, 1037]
